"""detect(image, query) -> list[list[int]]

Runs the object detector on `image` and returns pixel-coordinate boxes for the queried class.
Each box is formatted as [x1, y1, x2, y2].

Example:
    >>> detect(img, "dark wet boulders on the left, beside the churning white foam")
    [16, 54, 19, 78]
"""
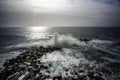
[0, 46, 61, 80]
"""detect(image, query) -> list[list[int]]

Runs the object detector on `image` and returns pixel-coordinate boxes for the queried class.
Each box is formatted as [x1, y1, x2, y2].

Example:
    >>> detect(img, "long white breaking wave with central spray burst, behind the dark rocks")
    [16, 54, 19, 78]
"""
[6, 34, 120, 59]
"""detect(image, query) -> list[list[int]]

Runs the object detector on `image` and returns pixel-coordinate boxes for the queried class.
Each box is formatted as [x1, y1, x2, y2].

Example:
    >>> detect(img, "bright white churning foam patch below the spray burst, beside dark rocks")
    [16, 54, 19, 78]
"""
[41, 49, 79, 67]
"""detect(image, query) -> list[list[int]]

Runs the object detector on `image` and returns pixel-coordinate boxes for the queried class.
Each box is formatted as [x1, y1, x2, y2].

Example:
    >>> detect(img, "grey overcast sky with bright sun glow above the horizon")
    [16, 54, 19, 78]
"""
[0, 0, 120, 27]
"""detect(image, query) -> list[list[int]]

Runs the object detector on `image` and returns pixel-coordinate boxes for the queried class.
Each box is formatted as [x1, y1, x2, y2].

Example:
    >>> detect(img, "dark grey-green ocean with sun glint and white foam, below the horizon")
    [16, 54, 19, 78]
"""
[0, 27, 120, 80]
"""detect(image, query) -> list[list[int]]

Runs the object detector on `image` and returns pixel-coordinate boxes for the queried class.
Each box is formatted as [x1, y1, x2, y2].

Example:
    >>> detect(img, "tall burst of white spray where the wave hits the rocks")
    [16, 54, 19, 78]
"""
[43, 34, 80, 47]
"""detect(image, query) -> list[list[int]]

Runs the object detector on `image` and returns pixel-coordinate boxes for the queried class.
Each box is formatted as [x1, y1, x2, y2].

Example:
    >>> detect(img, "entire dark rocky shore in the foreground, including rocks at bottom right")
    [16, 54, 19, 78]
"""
[0, 46, 104, 80]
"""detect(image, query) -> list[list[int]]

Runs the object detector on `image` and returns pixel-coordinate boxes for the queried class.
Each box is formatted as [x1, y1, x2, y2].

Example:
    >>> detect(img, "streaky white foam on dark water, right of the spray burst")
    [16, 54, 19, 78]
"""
[88, 39, 120, 57]
